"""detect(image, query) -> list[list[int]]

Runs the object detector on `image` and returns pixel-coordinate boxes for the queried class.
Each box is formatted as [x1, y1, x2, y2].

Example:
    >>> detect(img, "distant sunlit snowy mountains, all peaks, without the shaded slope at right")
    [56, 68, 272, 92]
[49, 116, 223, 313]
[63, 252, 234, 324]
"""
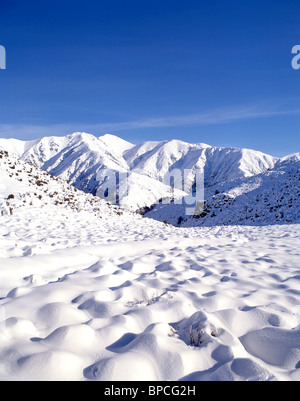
[0, 133, 277, 211]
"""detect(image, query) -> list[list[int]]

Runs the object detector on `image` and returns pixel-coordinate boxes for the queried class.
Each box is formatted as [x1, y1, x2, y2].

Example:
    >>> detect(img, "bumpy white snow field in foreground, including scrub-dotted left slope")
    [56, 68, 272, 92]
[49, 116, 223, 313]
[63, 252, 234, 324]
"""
[0, 148, 300, 381]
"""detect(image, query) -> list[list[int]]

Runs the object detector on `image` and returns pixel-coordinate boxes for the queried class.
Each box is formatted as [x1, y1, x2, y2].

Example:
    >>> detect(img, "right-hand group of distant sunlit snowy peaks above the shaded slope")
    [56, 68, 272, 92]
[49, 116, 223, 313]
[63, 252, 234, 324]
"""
[124, 140, 277, 186]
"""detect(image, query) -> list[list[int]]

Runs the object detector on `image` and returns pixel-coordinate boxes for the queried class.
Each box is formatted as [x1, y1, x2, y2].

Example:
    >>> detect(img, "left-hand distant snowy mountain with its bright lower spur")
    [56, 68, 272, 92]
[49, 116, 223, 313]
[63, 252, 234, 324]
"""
[0, 133, 188, 211]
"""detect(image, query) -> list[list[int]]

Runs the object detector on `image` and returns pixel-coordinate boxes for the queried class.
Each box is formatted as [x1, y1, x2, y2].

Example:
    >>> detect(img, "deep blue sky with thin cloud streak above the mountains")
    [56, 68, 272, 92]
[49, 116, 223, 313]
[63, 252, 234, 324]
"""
[0, 0, 300, 156]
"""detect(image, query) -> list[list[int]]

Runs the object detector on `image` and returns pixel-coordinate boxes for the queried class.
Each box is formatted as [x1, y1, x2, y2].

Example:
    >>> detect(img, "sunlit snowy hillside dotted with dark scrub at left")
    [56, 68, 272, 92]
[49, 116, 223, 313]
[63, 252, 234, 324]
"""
[0, 149, 120, 216]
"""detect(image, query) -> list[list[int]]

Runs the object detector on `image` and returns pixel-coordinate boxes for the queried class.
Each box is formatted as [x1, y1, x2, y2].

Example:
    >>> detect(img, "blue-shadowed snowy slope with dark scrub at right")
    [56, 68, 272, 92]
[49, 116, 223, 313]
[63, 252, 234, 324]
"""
[146, 153, 300, 227]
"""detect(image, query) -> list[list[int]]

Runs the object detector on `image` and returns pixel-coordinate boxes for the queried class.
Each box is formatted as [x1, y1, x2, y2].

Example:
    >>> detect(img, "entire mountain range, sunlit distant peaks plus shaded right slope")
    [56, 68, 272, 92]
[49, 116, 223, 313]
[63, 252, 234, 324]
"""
[0, 133, 300, 225]
